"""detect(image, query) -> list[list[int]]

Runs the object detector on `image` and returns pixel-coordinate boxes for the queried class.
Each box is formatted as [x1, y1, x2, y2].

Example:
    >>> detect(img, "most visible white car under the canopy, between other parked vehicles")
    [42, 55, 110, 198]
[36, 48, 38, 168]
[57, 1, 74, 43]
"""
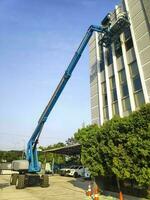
[66, 166, 85, 178]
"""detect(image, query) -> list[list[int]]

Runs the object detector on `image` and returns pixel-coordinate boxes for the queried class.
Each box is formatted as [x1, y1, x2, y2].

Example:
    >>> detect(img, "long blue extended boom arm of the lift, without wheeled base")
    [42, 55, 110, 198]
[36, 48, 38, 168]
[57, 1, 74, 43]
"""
[26, 25, 104, 172]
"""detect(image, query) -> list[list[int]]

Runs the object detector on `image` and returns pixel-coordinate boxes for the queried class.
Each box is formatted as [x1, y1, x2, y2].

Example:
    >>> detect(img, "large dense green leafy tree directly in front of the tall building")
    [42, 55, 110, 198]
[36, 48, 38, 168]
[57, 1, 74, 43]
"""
[75, 104, 150, 186]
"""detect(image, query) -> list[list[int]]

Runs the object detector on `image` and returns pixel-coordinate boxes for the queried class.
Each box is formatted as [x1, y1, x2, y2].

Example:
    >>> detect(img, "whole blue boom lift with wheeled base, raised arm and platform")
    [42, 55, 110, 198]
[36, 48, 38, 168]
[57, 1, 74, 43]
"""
[10, 10, 129, 189]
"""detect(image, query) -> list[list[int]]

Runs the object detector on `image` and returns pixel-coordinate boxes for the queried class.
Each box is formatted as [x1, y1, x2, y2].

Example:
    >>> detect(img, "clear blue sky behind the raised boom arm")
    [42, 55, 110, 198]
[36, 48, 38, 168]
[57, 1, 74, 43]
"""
[0, 0, 120, 149]
